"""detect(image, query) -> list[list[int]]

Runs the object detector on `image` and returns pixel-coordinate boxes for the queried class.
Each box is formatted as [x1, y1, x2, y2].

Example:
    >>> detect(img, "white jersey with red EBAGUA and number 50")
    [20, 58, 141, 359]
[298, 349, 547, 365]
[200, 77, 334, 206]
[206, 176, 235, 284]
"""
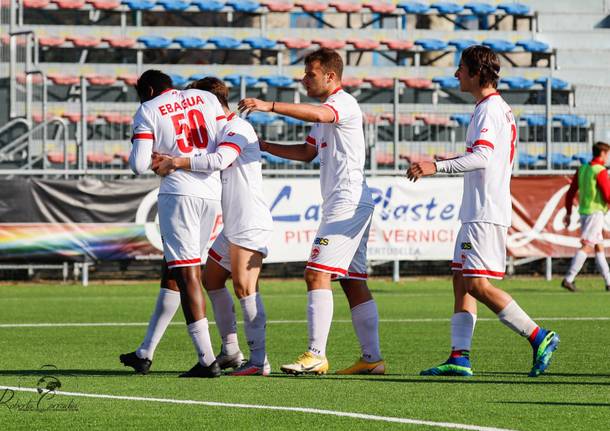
[130, 89, 226, 200]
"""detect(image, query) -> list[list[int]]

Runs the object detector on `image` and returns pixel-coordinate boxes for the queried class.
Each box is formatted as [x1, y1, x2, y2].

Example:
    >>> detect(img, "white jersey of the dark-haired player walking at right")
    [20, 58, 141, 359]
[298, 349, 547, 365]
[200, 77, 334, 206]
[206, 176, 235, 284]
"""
[436, 93, 517, 226]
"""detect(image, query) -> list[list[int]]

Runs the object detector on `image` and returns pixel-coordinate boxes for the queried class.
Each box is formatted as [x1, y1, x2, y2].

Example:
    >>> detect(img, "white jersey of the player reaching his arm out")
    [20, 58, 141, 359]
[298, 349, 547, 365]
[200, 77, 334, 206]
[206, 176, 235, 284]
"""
[306, 88, 374, 215]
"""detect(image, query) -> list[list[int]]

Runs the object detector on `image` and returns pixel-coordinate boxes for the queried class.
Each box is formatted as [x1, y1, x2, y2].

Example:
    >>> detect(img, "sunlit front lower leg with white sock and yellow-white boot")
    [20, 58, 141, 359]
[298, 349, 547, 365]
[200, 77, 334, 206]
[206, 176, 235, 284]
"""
[280, 268, 333, 374]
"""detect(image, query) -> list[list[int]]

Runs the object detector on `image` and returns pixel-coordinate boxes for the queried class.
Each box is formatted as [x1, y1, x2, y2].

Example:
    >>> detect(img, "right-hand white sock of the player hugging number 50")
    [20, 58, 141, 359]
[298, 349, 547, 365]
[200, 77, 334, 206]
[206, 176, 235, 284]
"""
[239, 293, 267, 365]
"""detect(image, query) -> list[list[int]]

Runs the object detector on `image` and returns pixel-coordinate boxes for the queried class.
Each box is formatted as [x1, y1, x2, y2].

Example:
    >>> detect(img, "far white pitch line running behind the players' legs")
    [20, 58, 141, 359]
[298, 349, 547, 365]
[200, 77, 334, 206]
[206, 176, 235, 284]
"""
[0, 317, 610, 329]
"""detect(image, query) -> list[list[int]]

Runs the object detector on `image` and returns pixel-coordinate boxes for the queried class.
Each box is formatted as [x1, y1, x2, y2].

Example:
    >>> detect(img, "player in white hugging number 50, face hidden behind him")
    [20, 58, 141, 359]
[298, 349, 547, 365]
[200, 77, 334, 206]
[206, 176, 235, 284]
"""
[153, 78, 273, 376]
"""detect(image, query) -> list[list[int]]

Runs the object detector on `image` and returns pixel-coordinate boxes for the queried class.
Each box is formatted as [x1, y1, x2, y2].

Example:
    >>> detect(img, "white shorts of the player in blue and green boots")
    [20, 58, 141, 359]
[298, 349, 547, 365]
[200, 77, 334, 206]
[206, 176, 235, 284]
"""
[451, 222, 508, 279]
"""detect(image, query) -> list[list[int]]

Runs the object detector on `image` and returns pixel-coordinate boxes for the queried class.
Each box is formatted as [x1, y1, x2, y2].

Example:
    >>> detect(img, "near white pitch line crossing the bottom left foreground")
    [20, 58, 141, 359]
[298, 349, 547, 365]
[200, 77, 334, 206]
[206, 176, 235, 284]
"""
[0, 386, 514, 431]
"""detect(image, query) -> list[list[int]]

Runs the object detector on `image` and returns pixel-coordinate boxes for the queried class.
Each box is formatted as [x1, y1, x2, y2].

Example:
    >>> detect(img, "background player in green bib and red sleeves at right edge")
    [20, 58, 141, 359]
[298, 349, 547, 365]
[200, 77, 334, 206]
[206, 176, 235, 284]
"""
[561, 142, 610, 292]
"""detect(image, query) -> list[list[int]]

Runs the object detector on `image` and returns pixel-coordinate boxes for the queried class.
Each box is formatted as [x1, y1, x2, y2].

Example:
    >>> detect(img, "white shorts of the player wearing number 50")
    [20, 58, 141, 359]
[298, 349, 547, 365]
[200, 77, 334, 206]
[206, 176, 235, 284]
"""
[158, 194, 222, 268]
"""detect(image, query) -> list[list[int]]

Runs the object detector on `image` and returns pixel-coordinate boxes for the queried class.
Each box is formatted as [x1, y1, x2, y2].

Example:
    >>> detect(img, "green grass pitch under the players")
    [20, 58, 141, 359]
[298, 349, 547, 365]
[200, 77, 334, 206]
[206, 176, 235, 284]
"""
[0, 277, 610, 431]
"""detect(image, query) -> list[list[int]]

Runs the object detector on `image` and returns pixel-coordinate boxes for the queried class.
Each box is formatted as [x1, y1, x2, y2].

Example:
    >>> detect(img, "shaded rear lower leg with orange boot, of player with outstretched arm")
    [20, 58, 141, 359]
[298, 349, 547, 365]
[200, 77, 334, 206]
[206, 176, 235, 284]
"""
[337, 279, 385, 374]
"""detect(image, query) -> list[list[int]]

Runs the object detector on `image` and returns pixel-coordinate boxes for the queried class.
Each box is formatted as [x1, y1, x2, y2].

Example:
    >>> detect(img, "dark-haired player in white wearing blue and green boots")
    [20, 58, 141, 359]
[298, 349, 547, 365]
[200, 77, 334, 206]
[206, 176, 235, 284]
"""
[407, 45, 559, 377]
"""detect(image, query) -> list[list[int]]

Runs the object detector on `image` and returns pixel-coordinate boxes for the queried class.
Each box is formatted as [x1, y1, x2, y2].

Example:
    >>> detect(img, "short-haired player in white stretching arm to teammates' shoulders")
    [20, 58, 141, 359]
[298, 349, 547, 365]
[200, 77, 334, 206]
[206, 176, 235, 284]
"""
[239, 49, 385, 374]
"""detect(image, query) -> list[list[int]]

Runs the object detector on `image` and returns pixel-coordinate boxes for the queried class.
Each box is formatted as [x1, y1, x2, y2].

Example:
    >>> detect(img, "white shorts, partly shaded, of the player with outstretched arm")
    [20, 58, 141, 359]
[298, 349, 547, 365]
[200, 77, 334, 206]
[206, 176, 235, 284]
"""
[306, 206, 373, 280]
